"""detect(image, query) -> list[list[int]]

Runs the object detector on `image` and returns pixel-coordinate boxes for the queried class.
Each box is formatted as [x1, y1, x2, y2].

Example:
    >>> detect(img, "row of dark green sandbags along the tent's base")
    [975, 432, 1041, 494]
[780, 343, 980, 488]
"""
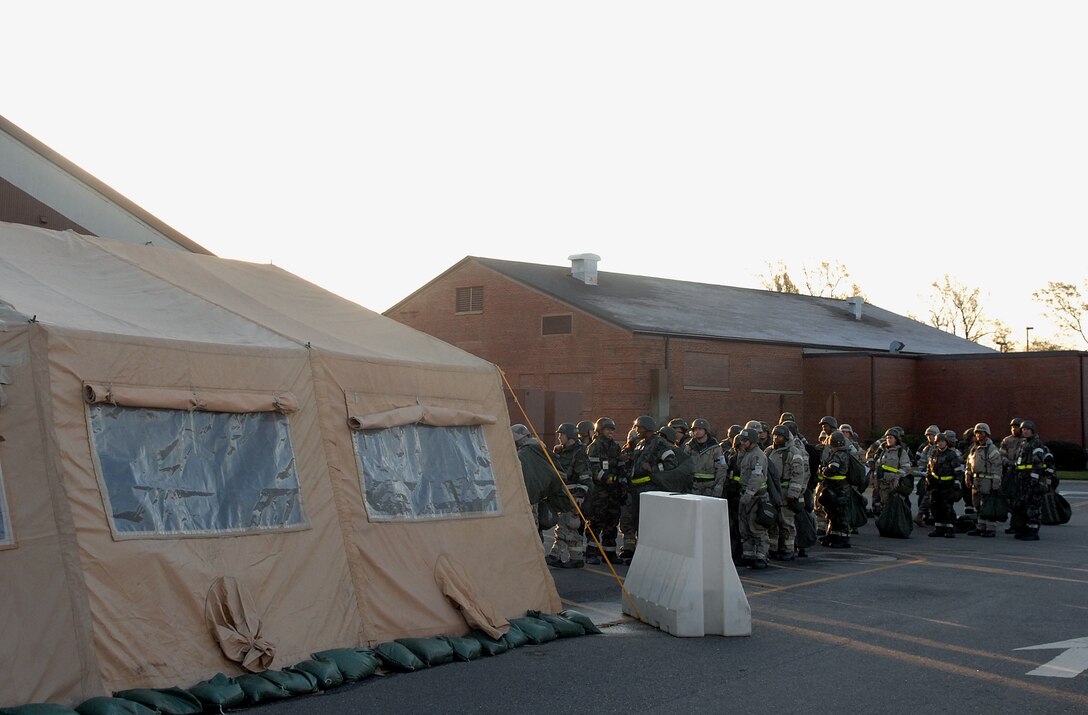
[0, 609, 601, 715]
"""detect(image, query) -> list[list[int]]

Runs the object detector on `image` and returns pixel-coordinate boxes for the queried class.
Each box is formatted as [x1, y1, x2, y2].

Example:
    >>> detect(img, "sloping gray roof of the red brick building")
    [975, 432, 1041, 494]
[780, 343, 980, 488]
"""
[469, 257, 994, 355]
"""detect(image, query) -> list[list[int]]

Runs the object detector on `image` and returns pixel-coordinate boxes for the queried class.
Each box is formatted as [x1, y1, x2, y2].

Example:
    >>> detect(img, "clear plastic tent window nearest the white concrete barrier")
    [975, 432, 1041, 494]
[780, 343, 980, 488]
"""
[353, 424, 499, 521]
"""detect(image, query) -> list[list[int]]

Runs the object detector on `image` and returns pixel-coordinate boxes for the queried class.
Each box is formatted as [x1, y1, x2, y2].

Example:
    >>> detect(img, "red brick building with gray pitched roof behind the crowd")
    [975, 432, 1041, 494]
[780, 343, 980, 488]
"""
[385, 255, 1086, 443]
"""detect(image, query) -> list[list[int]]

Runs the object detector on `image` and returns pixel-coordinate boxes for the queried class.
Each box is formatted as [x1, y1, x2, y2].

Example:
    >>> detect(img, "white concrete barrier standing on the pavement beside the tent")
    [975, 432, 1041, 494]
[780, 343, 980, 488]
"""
[623, 492, 752, 637]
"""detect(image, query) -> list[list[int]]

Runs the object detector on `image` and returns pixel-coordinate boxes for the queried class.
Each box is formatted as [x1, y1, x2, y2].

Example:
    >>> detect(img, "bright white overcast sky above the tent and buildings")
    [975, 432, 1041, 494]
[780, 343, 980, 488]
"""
[0, 0, 1088, 347]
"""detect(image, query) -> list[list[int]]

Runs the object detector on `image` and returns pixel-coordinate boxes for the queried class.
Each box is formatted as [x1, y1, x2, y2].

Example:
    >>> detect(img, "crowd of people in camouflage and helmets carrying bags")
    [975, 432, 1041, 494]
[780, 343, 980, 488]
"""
[511, 412, 1055, 569]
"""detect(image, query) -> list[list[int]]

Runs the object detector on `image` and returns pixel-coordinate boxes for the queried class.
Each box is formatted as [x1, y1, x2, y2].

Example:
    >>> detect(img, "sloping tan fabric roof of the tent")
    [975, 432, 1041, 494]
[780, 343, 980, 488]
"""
[0, 222, 493, 370]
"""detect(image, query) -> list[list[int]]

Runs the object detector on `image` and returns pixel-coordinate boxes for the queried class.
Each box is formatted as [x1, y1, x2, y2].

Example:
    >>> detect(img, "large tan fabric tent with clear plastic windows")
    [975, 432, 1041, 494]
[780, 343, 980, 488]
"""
[0, 223, 560, 705]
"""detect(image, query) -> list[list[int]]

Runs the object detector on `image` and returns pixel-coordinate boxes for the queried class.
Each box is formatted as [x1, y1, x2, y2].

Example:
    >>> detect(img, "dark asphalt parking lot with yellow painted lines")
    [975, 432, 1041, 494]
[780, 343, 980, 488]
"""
[254, 491, 1088, 715]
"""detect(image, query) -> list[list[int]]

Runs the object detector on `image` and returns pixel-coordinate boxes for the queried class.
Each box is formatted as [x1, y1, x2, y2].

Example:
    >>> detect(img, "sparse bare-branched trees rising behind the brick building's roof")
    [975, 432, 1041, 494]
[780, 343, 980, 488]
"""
[758, 261, 1088, 353]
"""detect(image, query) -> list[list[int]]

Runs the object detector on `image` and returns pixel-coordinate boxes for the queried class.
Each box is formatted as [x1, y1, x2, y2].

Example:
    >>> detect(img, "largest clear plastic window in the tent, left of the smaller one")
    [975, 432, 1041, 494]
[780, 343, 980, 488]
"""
[87, 404, 309, 539]
